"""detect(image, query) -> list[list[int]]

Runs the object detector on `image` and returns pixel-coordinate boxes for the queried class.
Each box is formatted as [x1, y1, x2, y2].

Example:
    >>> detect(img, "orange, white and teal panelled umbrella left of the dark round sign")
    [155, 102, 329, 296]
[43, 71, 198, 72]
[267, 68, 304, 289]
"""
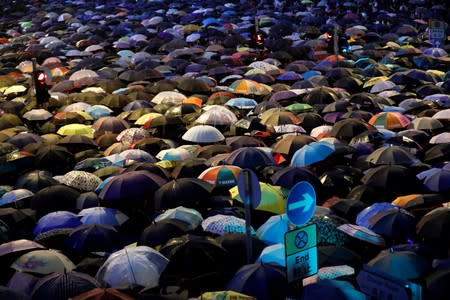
[198, 165, 241, 187]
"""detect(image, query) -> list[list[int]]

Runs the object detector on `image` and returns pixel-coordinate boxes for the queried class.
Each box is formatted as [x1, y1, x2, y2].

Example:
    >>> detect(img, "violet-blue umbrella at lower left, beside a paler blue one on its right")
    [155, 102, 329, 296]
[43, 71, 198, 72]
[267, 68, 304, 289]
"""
[33, 210, 81, 236]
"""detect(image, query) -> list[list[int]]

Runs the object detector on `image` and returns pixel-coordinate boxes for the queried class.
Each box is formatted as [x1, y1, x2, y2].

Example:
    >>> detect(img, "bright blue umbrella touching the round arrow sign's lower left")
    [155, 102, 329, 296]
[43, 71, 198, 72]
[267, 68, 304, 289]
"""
[256, 214, 289, 245]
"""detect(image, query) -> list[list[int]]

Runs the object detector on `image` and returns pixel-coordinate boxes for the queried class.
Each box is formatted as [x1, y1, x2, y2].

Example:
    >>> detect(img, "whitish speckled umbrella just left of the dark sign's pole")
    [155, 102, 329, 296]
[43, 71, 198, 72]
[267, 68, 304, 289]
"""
[202, 214, 255, 235]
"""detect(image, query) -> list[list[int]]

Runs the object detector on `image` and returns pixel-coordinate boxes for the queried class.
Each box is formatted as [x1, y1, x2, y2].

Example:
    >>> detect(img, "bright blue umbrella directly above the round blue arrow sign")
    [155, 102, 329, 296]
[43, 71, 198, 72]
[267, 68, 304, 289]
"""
[291, 142, 334, 167]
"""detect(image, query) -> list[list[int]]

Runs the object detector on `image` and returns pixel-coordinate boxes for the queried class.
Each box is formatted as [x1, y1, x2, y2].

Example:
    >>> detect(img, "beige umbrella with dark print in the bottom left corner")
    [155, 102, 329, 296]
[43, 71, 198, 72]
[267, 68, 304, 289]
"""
[11, 250, 75, 275]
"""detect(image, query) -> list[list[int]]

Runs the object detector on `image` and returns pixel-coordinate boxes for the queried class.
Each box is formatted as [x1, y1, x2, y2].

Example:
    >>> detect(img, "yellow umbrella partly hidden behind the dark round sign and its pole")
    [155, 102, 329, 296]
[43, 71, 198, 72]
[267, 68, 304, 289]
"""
[230, 182, 289, 214]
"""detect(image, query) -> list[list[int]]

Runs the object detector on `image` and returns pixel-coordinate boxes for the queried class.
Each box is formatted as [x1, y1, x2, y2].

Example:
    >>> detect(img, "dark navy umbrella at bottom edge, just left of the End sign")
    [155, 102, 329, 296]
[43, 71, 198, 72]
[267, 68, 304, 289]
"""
[226, 262, 291, 300]
